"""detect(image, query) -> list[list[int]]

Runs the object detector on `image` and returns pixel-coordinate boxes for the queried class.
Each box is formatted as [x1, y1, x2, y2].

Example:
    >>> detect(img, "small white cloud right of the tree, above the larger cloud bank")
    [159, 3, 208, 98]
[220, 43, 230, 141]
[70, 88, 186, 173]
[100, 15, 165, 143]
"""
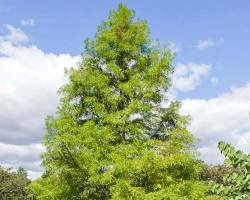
[172, 63, 211, 91]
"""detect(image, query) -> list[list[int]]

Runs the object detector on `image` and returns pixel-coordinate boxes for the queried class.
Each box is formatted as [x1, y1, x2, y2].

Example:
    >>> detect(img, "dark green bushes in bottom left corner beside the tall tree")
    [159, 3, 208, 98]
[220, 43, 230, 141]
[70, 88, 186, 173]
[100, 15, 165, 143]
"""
[0, 167, 31, 200]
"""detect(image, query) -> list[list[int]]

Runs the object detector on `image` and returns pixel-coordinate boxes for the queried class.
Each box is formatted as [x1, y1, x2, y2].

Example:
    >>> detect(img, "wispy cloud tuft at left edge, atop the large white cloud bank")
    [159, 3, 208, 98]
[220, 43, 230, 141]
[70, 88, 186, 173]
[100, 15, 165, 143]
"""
[0, 24, 28, 44]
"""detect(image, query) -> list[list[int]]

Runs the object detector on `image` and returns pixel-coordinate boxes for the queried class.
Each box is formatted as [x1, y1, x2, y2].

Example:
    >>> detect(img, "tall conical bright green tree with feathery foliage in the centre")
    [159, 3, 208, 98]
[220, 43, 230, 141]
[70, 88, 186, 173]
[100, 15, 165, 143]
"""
[31, 4, 218, 200]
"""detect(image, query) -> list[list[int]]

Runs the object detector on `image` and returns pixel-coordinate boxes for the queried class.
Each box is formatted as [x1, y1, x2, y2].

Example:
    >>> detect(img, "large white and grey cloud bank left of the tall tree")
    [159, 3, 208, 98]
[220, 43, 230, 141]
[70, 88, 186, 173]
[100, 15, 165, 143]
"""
[0, 25, 79, 178]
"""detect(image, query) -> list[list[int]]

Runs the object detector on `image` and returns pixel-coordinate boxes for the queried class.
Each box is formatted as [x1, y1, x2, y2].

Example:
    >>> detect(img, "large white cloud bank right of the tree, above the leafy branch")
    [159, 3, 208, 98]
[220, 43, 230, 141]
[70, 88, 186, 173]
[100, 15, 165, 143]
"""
[182, 83, 250, 163]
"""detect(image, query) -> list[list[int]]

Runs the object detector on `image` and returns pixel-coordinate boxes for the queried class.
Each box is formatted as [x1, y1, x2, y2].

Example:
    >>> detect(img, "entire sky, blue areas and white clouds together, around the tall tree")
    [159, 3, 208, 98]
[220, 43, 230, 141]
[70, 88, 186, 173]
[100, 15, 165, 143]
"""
[0, 0, 250, 177]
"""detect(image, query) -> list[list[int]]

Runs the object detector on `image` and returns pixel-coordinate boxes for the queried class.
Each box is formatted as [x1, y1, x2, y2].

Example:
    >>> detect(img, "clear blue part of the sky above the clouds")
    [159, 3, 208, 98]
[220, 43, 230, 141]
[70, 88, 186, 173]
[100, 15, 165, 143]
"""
[0, 0, 250, 98]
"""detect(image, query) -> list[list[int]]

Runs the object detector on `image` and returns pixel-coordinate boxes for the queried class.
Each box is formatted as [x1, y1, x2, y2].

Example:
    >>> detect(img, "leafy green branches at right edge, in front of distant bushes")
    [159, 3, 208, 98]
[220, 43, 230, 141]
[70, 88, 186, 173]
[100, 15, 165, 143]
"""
[212, 142, 250, 200]
